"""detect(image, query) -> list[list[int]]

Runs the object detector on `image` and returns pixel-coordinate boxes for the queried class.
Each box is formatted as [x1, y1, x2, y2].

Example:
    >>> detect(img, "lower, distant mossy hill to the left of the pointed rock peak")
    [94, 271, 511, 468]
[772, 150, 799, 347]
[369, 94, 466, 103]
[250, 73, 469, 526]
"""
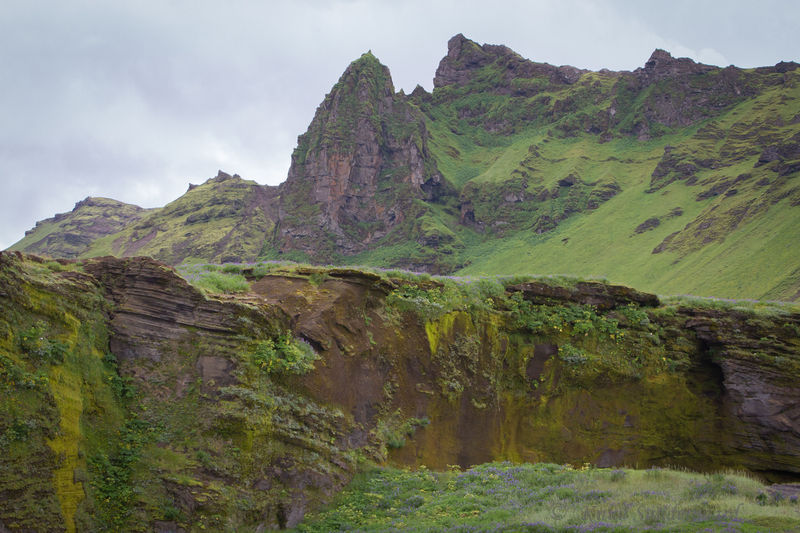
[17, 171, 276, 264]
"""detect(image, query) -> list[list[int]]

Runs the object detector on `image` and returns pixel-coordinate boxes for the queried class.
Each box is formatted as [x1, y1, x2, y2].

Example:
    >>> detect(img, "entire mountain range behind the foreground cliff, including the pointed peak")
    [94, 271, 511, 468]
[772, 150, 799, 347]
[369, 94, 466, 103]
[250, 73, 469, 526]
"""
[12, 35, 800, 300]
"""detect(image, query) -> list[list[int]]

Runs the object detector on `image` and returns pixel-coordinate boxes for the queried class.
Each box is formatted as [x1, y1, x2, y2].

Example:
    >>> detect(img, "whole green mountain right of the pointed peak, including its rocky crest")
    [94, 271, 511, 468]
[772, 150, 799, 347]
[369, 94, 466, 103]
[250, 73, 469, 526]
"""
[346, 37, 800, 300]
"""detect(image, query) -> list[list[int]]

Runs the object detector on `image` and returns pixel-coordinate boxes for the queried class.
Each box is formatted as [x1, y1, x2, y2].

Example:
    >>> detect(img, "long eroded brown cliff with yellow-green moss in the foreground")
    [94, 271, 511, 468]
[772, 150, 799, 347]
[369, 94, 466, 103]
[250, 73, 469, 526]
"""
[0, 253, 800, 531]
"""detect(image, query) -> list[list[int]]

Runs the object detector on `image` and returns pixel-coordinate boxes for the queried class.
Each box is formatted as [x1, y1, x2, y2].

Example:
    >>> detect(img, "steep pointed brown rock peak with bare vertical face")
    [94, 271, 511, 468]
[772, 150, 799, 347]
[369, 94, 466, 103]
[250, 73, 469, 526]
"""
[275, 53, 446, 261]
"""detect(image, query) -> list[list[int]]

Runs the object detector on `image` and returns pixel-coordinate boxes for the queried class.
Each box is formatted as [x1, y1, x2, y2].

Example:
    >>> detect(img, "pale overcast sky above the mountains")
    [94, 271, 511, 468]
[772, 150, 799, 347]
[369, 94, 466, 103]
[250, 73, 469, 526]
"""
[0, 0, 800, 249]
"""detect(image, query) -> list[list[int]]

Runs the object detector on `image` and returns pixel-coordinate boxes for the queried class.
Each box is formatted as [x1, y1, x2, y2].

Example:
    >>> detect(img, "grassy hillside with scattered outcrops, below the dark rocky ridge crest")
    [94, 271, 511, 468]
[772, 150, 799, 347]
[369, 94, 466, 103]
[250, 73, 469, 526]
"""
[355, 51, 800, 300]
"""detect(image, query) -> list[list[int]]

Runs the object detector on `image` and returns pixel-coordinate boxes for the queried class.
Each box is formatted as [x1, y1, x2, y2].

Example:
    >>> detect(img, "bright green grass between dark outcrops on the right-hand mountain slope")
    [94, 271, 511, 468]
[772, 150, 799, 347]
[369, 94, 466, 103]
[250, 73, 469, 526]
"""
[418, 65, 800, 300]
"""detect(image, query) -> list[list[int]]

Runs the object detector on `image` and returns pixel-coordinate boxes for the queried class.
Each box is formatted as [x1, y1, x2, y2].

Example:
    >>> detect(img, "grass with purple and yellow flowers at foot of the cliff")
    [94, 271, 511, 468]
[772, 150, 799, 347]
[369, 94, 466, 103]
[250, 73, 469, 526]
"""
[295, 463, 800, 533]
